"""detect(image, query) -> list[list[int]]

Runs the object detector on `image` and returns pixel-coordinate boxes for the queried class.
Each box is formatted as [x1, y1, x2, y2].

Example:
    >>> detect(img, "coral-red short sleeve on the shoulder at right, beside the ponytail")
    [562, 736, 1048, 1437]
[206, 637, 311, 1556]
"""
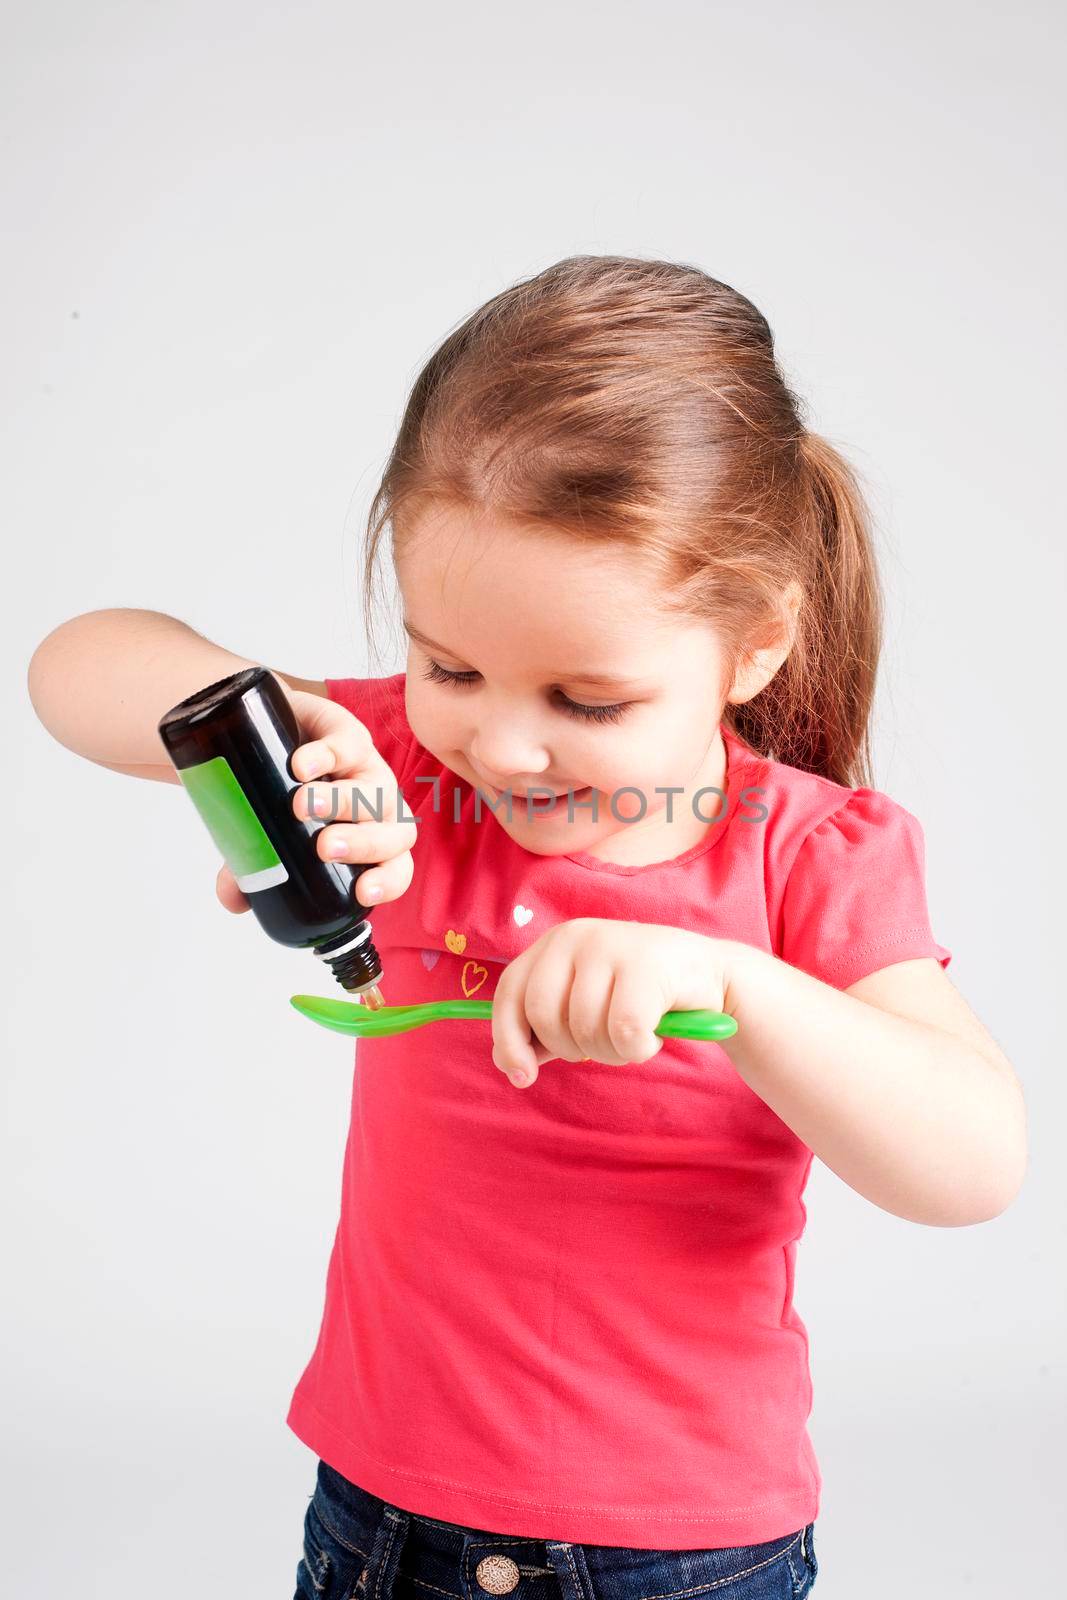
[779, 789, 952, 989]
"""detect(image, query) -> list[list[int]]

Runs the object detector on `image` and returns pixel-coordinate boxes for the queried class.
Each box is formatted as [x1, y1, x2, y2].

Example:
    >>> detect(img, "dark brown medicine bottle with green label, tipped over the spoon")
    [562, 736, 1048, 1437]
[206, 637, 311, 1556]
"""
[158, 667, 382, 1006]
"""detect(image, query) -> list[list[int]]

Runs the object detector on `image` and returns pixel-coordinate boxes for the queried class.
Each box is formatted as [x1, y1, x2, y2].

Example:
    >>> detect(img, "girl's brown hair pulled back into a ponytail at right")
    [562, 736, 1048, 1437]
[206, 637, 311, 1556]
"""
[363, 256, 883, 787]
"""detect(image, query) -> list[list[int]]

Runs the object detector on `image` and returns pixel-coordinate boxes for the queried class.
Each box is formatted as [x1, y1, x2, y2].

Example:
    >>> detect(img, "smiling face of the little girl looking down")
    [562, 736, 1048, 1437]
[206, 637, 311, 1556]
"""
[397, 507, 726, 862]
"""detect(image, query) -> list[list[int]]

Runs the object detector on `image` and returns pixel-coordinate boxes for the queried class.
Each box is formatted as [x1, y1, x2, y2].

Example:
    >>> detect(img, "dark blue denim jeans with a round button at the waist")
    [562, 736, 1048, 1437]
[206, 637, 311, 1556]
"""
[293, 1461, 819, 1600]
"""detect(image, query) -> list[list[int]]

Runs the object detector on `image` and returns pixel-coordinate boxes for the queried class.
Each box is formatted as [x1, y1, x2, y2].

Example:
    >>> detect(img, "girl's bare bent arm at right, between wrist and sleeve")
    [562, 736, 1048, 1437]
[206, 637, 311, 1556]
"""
[720, 941, 1027, 1227]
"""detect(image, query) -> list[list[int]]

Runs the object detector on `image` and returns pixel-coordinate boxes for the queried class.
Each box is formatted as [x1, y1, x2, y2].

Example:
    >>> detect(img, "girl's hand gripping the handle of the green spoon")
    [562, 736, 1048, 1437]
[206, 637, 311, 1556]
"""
[493, 917, 731, 1088]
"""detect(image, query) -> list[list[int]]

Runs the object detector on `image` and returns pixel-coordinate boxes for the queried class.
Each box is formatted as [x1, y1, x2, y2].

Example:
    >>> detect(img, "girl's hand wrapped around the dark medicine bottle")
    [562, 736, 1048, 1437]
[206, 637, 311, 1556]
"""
[214, 690, 418, 912]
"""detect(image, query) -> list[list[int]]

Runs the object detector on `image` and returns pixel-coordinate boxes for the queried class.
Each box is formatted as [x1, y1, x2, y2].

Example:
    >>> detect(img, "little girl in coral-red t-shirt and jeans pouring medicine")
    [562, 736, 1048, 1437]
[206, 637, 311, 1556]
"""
[30, 256, 1025, 1600]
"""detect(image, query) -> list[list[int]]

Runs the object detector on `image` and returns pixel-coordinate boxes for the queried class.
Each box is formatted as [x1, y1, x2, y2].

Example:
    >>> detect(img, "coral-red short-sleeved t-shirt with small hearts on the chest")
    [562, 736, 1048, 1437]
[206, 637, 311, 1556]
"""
[288, 674, 952, 1549]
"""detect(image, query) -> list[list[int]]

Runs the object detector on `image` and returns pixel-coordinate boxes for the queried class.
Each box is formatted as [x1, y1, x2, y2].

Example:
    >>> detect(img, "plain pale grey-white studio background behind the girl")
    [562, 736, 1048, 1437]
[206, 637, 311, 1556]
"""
[0, 0, 1065, 1600]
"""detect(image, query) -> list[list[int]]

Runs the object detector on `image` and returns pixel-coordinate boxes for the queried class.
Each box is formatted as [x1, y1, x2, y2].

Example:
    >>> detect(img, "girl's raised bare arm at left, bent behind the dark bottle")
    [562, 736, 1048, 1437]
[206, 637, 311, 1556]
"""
[27, 608, 326, 782]
